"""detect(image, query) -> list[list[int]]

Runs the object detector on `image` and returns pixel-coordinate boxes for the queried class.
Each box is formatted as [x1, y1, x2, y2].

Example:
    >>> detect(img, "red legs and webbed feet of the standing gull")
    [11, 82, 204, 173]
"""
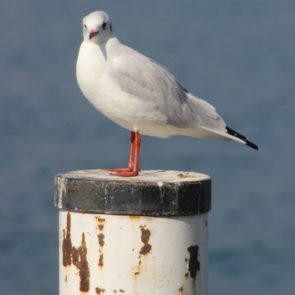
[109, 132, 141, 177]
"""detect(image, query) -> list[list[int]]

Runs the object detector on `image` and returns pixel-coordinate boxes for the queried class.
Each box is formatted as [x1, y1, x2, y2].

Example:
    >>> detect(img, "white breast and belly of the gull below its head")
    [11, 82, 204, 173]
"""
[76, 43, 171, 137]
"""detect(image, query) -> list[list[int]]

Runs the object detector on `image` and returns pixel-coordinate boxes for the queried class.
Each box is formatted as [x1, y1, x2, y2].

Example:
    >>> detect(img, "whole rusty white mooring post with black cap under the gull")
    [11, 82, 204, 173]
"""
[55, 170, 211, 295]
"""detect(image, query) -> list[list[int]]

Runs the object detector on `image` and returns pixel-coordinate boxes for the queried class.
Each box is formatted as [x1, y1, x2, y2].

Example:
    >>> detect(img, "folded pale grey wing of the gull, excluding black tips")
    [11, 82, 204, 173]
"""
[113, 48, 225, 131]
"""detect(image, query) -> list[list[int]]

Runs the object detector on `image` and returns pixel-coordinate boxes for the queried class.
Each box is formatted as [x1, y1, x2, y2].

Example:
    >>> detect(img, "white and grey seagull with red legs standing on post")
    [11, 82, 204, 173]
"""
[76, 11, 258, 177]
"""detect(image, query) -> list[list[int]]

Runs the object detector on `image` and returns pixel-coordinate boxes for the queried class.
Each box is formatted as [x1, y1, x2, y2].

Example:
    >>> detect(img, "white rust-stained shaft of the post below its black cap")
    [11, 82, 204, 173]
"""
[59, 210, 208, 295]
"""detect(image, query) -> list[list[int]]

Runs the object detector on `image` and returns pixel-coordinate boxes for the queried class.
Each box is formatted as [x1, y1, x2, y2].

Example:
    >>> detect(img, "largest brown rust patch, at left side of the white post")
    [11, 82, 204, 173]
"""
[62, 212, 90, 292]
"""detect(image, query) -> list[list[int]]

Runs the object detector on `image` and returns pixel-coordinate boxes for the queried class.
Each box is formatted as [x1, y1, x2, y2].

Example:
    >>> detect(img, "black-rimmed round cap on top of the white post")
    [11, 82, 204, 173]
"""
[54, 170, 211, 216]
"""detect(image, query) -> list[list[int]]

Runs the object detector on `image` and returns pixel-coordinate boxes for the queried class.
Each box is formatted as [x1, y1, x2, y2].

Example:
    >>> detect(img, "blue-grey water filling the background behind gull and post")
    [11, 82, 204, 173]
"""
[0, 0, 295, 295]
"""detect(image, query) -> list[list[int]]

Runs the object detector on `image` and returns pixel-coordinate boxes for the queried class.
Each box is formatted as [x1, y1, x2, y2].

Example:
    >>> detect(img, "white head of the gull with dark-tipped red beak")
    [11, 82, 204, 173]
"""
[82, 11, 113, 44]
